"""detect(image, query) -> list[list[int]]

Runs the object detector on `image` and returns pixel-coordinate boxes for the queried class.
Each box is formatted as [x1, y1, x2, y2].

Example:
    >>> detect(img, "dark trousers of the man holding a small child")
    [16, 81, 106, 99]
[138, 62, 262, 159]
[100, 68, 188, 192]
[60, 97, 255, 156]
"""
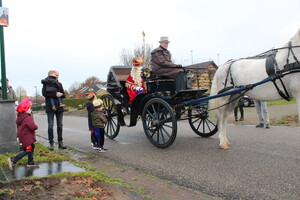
[47, 112, 63, 144]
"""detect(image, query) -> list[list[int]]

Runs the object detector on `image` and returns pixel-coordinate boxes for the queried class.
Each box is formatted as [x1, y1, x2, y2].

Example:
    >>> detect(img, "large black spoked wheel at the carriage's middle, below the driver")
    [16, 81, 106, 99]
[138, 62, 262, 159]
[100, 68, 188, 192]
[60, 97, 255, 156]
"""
[142, 98, 177, 148]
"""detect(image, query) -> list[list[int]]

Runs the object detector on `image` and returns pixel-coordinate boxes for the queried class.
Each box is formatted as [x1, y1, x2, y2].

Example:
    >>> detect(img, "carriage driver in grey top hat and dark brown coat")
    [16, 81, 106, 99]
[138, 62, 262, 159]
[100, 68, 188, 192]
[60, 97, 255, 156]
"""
[151, 37, 191, 92]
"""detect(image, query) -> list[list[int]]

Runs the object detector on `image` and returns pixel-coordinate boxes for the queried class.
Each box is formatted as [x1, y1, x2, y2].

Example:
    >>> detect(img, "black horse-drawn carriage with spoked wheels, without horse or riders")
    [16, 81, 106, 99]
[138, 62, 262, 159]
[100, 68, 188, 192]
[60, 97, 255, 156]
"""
[101, 66, 217, 148]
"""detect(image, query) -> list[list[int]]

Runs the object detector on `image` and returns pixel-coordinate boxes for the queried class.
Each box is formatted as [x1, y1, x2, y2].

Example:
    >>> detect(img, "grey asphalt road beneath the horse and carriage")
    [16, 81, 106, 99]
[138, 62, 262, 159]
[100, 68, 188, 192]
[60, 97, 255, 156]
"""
[34, 114, 300, 199]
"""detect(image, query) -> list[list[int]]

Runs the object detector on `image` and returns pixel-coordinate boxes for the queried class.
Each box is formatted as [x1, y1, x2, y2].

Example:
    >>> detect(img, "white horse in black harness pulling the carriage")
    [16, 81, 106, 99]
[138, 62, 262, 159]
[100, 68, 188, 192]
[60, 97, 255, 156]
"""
[209, 29, 300, 149]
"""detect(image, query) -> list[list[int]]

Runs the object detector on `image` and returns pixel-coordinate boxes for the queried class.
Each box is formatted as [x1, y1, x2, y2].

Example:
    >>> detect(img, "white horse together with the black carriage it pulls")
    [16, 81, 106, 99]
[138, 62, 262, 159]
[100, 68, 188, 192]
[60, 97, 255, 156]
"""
[102, 29, 300, 149]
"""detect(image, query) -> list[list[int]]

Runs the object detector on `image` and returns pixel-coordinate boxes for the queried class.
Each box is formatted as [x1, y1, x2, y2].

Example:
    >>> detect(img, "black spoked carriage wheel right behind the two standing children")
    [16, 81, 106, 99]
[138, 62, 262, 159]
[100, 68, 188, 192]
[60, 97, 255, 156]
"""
[101, 94, 120, 139]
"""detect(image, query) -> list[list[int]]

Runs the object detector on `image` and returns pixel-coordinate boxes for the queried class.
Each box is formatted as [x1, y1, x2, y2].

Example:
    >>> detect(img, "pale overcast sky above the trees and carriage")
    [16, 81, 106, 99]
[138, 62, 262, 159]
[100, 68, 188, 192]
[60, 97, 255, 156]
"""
[2, 0, 300, 96]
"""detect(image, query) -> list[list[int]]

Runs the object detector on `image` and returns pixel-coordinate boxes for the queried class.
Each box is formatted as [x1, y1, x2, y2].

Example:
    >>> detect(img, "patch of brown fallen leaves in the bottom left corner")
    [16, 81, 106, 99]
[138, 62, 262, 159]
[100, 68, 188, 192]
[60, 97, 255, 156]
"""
[0, 176, 113, 200]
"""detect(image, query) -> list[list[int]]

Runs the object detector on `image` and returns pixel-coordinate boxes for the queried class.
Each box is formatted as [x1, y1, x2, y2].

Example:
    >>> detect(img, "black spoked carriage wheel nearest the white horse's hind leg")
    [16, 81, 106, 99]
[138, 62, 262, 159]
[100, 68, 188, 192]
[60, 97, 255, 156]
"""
[188, 106, 218, 137]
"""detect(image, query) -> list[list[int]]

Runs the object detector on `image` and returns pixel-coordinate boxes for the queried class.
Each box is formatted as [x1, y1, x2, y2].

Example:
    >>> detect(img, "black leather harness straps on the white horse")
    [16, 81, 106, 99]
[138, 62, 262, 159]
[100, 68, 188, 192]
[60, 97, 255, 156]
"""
[219, 41, 300, 101]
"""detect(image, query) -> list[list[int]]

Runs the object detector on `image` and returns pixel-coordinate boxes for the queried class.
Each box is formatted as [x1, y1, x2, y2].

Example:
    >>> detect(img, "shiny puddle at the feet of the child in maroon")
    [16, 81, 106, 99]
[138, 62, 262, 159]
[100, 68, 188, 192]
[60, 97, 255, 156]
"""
[0, 161, 85, 182]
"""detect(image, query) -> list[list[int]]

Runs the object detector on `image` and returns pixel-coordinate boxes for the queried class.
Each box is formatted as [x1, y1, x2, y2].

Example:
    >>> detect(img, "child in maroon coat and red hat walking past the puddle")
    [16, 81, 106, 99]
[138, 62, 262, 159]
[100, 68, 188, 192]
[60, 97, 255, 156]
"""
[8, 102, 38, 170]
